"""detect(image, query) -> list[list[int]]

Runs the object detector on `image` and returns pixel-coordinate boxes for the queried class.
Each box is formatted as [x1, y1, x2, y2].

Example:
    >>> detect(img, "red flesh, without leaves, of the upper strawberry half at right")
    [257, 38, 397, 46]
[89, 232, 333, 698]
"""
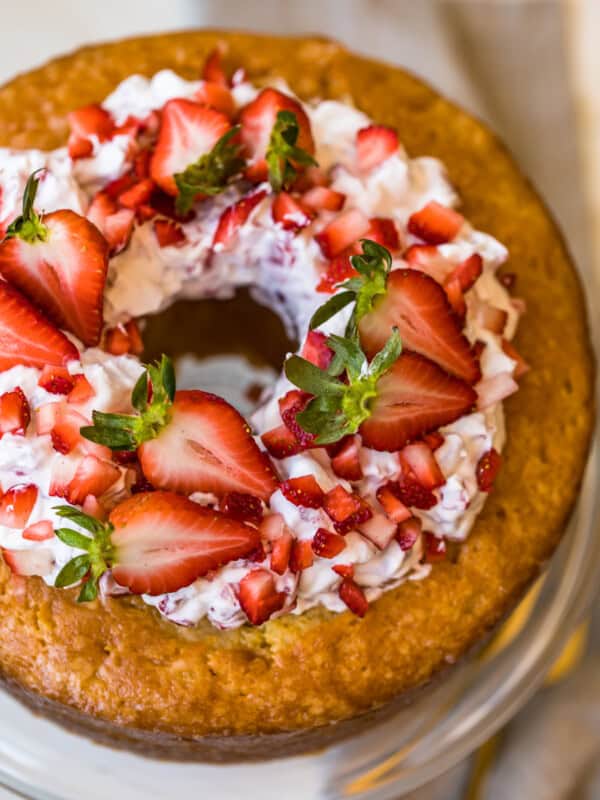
[359, 269, 480, 383]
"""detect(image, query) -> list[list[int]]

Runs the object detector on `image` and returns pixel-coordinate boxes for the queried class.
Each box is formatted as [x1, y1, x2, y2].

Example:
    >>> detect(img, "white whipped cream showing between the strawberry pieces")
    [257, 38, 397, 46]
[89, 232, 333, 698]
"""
[0, 70, 519, 628]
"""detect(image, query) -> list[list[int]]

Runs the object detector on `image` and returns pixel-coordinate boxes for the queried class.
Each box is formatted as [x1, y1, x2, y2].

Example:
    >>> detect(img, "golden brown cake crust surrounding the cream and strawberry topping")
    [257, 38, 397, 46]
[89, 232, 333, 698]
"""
[0, 31, 594, 757]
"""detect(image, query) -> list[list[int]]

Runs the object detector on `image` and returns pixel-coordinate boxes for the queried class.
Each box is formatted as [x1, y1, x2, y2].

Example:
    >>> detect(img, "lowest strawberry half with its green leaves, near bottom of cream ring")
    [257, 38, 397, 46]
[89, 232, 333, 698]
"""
[55, 491, 260, 601]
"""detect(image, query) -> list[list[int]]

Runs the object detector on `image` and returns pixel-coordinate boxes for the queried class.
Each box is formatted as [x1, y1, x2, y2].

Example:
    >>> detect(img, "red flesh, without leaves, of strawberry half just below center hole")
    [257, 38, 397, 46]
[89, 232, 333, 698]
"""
[139, 390, 277, 501]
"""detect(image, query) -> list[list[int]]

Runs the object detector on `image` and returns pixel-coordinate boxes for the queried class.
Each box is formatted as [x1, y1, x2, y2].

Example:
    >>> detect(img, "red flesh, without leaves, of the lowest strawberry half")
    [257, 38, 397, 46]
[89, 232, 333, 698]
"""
[109, 492, 260, 595]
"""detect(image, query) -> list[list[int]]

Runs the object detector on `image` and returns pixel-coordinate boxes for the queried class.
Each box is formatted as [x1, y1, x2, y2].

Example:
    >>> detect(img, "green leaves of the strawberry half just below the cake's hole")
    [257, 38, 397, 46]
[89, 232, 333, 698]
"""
[80, 355, 175, 450]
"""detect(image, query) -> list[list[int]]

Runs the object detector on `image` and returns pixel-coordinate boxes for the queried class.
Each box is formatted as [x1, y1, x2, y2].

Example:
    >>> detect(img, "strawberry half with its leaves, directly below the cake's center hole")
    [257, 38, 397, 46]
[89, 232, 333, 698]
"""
[81, 356, 277, 501]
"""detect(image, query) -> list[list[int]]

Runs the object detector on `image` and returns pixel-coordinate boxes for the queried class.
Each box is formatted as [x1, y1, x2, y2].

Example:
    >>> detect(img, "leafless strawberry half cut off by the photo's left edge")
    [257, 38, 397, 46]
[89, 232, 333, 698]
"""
[0, 282, 79, 370]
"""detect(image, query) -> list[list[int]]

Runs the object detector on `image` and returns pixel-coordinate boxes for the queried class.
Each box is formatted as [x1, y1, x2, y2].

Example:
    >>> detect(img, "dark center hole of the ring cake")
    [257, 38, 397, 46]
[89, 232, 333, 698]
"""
[142, 289, 297, 416]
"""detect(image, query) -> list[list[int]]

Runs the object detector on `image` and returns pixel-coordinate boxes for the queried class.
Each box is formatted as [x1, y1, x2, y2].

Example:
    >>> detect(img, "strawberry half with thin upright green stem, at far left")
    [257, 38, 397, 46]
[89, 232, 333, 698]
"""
[0, 173, 108, 346]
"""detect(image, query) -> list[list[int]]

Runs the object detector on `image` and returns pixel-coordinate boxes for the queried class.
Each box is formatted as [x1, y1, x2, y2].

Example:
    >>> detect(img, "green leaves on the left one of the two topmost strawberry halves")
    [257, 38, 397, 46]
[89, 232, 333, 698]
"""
[173, 125, 246, 214]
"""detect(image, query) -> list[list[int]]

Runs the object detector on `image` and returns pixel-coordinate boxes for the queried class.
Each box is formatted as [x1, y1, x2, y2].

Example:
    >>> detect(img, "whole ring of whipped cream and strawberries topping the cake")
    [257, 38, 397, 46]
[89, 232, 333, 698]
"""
[0, 56, 526, 628]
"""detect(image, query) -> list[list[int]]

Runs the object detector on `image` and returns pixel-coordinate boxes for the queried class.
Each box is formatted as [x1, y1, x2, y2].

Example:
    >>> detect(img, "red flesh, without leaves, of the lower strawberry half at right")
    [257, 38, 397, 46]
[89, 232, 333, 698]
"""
[360, 352, 477, 450]
